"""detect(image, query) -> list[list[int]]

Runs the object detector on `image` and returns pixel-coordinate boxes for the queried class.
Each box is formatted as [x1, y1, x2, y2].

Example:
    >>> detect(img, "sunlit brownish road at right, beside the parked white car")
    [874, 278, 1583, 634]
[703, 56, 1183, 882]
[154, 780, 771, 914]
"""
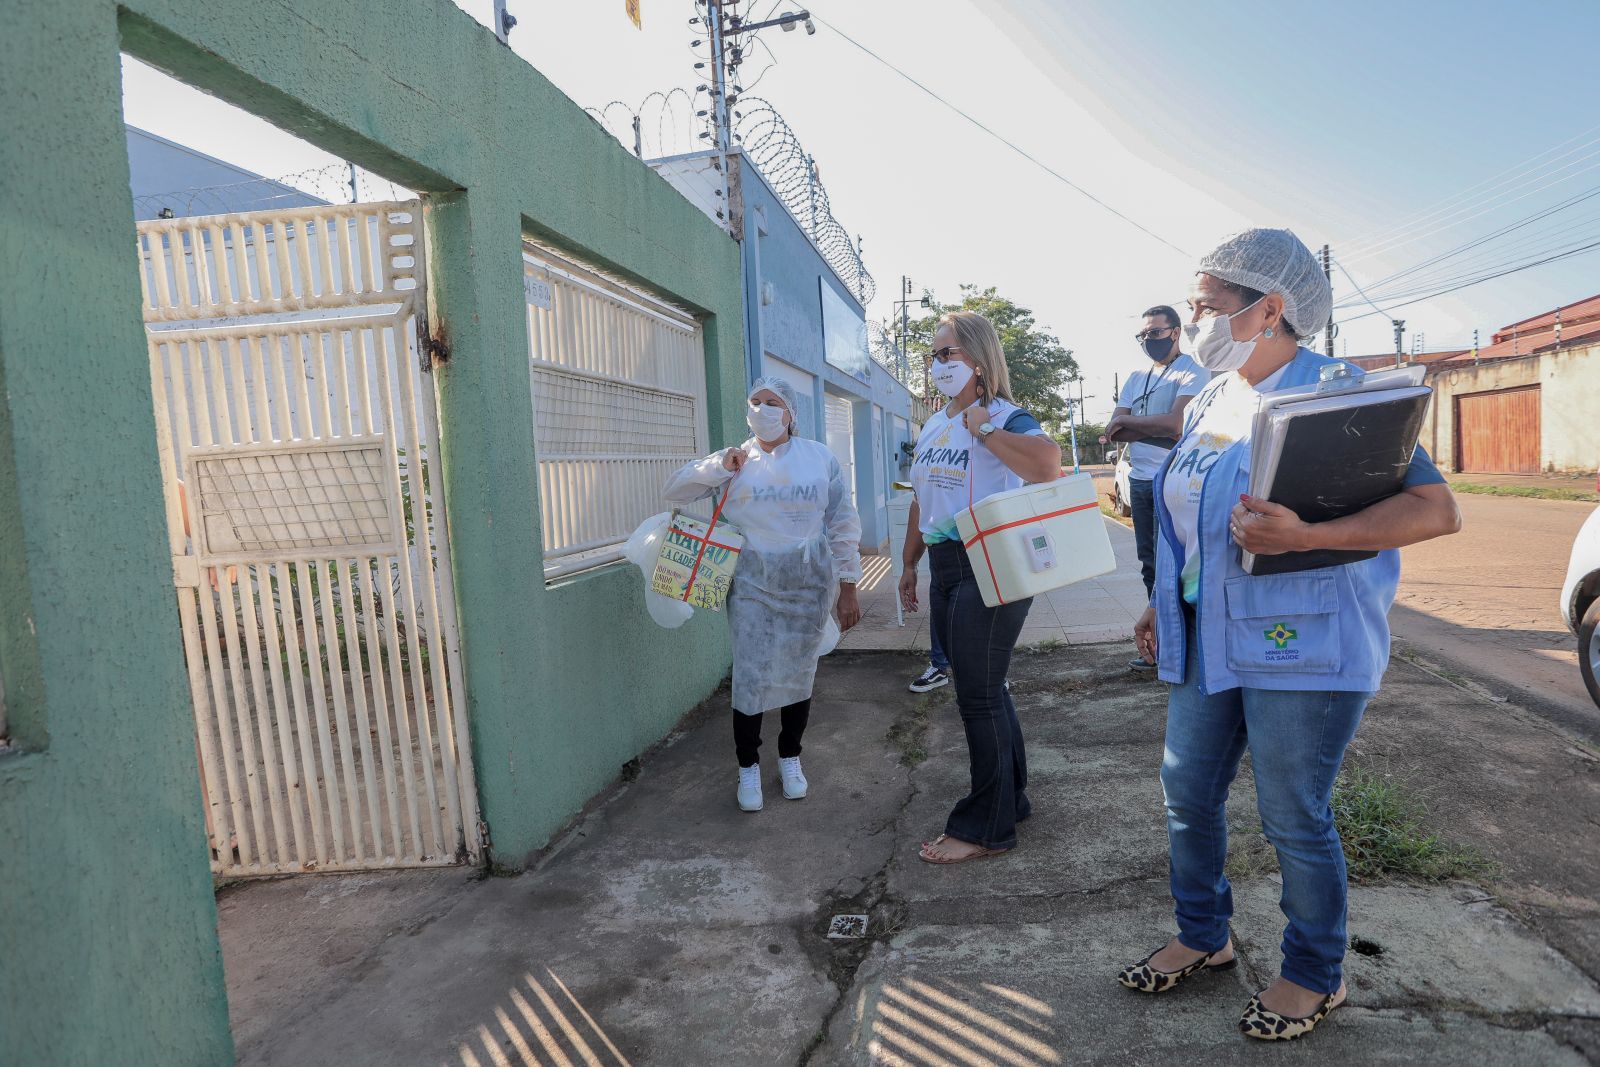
[1390, 493, 1600, 739]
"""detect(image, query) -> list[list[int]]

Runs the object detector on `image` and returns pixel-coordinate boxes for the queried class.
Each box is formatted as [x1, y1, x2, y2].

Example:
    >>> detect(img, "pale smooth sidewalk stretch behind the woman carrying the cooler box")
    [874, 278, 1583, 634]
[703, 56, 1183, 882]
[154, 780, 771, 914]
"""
[838, 518, 1149, 654]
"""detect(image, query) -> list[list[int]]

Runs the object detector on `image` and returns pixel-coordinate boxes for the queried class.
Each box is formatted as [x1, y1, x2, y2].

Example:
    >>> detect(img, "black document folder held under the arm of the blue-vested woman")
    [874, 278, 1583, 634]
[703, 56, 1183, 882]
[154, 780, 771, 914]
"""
[1240, 386, 1432, 574]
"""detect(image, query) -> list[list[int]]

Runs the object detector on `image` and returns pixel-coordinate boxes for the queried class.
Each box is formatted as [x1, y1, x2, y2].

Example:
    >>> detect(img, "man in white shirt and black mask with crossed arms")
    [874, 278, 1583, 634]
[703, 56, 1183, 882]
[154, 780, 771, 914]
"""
[1106, 304, 1211, 670]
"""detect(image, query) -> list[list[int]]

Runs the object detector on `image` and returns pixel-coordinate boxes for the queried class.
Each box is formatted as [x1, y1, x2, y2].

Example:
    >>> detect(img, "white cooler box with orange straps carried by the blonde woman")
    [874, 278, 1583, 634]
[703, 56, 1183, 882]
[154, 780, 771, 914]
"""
[955, 474, 1117, 608]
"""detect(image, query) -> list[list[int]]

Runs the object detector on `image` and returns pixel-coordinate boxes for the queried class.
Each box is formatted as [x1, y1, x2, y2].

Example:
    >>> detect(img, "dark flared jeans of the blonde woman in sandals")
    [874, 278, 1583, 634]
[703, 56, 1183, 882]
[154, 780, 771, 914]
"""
[928, 541, 1034, 848]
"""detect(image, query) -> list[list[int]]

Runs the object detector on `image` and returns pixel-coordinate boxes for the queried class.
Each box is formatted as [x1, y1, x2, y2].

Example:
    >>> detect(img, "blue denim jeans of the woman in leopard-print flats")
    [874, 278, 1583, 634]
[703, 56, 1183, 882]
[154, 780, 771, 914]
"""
[1162, 619, 1371, 993]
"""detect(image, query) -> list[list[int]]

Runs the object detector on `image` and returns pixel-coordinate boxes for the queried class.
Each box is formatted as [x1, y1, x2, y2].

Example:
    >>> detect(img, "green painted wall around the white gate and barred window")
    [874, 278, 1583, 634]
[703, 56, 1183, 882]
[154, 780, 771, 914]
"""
[0, 0, 744, 1065]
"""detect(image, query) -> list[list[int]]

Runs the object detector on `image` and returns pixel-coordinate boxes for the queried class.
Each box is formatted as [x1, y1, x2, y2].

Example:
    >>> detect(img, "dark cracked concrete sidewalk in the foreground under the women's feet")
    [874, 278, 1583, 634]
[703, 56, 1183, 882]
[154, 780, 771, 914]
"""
[219, 646, 1600, 1067]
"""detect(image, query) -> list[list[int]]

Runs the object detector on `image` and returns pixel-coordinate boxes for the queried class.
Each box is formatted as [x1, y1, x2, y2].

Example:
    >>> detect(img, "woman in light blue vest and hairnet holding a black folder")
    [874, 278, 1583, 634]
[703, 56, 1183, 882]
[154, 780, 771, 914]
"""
[1120, 230, 1461, 1040]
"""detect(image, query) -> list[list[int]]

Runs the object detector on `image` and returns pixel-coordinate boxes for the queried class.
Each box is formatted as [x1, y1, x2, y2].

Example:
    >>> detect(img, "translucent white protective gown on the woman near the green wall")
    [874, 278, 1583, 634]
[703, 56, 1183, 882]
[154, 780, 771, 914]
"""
[666, 437, 861, 715]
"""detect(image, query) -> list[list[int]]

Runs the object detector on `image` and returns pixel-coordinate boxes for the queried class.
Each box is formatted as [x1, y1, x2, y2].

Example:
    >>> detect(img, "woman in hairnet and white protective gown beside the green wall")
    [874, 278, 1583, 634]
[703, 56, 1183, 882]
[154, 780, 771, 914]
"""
[666, 378, 861, 811]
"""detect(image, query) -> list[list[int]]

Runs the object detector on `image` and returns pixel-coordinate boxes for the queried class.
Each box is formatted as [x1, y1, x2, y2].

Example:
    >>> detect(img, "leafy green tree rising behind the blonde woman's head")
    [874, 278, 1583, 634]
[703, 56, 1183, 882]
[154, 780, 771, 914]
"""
[906, 292, 1078, 429]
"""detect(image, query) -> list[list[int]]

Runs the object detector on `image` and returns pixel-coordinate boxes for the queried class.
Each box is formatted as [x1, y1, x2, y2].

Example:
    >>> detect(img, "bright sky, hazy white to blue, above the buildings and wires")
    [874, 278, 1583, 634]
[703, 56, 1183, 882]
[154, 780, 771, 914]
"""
[126, 0, 1600, 414]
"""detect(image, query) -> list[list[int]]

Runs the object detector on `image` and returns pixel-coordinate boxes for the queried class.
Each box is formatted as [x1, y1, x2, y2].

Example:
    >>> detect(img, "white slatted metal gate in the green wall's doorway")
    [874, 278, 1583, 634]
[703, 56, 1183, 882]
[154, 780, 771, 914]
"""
[139, 202, 480, 875]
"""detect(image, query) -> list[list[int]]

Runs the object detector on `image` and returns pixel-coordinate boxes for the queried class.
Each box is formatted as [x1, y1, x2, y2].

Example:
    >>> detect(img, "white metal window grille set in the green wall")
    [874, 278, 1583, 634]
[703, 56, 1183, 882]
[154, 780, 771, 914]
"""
[523, 242, 709, 581]
